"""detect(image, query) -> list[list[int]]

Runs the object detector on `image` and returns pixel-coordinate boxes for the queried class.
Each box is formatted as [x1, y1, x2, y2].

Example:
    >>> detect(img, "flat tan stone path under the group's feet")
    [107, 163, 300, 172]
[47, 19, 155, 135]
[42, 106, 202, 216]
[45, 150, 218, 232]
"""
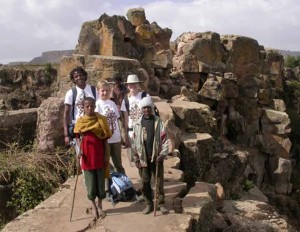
[2, 150, 191, 232]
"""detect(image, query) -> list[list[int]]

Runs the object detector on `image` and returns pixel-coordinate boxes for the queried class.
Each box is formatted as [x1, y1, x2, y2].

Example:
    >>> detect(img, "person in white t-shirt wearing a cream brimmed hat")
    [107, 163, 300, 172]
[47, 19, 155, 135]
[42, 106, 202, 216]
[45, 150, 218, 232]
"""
[121, 74, 150, 159]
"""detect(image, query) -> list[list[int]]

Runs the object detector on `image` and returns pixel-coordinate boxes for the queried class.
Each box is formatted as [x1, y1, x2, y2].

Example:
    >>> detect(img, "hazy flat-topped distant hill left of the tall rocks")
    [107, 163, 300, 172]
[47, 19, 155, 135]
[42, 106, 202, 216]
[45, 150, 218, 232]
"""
[28, 50, 74, 64]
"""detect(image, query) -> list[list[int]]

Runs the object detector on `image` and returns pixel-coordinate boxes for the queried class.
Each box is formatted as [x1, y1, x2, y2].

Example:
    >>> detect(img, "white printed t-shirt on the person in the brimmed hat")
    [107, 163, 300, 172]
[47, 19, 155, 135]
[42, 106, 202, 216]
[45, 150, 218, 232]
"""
[121, 92, 150, 132]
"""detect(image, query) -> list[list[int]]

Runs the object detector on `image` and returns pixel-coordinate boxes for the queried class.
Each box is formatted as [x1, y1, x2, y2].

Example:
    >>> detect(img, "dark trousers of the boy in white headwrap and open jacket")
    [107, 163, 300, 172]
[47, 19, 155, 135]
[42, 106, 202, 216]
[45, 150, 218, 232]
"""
[139, 160, 165, 205]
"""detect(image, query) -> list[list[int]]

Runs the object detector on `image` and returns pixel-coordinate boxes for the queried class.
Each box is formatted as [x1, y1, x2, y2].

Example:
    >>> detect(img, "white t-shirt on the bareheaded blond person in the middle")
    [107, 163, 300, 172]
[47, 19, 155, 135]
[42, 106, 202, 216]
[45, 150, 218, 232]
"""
[95, 99, 121, 143]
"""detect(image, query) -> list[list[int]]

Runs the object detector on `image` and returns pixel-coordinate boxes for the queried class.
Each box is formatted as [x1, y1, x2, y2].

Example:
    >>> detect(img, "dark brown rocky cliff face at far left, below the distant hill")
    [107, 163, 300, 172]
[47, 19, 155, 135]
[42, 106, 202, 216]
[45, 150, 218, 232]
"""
[0, 66, 57, 110]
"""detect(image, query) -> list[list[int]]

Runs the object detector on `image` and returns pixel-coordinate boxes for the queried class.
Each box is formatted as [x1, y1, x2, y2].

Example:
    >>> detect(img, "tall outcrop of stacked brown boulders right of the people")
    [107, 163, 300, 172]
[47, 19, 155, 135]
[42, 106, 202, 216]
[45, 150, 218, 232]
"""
[171, 32, 291, 197]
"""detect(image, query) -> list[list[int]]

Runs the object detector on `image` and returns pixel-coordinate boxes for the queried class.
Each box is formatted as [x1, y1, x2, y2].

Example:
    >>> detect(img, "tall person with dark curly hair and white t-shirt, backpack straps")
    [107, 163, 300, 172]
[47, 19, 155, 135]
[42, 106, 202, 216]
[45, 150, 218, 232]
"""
[64, 67, 98, 148]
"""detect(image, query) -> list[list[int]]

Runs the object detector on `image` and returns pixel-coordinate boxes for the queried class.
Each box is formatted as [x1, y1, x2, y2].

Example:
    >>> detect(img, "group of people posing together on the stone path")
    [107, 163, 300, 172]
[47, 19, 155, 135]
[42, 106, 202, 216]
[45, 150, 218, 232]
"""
[64, 67, 168, 217]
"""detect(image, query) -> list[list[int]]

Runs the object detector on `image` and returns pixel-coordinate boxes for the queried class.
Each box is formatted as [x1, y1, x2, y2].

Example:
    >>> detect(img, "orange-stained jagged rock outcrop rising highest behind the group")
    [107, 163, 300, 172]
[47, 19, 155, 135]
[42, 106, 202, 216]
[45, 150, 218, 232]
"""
[75, 8, 173, 95]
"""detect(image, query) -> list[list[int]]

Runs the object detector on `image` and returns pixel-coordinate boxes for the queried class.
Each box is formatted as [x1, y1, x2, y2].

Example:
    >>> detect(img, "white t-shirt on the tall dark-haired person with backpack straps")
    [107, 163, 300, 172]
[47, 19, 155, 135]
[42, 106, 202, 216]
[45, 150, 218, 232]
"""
[64, 84, 98, 123]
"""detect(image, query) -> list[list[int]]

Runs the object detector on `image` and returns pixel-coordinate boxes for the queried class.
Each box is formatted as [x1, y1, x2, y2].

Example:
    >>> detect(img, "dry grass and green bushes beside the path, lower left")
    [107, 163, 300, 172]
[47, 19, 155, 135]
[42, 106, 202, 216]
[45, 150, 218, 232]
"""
[0, 143, 76, 218]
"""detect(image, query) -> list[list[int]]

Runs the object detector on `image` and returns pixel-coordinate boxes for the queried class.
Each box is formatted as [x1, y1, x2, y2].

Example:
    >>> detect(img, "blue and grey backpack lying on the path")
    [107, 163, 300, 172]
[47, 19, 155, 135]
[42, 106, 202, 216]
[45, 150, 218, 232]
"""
[109, 172, 136, 204]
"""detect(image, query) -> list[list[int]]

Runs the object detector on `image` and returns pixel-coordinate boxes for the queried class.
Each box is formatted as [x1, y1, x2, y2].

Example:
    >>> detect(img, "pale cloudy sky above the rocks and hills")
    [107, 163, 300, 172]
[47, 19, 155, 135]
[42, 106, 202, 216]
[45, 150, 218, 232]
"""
[0, 0, 300, 64]
